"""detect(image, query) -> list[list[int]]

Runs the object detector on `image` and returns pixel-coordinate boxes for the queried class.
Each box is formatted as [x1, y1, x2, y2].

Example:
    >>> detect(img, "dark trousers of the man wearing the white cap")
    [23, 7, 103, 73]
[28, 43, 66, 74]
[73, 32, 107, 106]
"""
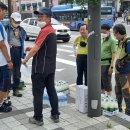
[10, 47, 21, 91]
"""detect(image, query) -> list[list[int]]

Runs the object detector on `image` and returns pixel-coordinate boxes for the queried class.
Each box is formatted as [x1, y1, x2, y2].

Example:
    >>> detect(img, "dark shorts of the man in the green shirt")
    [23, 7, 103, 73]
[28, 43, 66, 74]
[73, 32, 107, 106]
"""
[101, 65, 112, 92]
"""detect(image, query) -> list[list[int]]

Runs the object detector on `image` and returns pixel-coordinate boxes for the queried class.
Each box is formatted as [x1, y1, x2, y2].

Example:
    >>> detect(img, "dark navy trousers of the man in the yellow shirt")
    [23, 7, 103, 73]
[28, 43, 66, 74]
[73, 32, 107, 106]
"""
[76, 55, 87, 86]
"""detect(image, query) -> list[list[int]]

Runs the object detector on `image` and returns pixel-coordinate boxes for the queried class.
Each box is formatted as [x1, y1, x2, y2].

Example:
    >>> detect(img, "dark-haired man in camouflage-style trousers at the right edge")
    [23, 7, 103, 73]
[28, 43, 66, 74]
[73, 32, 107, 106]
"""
[113, 24, 130, 116]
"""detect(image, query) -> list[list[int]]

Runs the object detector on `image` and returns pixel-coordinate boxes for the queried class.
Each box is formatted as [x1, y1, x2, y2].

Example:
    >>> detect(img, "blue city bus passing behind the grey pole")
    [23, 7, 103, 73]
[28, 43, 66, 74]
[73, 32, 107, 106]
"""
[51, 4, 114, 30]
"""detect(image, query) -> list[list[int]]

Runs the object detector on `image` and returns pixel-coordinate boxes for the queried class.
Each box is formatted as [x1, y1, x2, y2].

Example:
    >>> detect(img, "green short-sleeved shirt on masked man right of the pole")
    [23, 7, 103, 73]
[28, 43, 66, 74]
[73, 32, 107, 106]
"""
[101, 36, 117, 65]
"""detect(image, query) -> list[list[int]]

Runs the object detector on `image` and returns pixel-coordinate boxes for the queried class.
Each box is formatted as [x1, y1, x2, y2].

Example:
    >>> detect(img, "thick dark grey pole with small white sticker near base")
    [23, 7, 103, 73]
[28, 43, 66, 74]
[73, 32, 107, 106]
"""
[87, 0, 101, 117]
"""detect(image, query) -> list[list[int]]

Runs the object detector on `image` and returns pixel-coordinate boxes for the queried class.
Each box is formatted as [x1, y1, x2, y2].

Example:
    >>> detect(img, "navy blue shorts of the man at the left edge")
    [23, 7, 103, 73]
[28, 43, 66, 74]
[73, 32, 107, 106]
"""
[0, 65, 11, 92]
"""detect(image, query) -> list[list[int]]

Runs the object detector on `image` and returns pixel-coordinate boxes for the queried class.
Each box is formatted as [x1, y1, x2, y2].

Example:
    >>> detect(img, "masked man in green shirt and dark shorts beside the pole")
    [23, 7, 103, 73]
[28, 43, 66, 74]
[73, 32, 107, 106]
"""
[101, 24, 116, 96]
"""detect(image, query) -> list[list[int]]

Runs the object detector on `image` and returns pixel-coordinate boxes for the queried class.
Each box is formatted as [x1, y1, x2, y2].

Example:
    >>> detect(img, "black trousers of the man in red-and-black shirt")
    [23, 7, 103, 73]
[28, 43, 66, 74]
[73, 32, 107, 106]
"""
[31, 73, 59, 120]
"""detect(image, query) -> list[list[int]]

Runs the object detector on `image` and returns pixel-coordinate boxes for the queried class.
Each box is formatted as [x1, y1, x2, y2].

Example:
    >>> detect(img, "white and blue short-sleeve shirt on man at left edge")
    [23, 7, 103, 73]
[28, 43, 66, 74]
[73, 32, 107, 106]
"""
[0, 22, 10, 66]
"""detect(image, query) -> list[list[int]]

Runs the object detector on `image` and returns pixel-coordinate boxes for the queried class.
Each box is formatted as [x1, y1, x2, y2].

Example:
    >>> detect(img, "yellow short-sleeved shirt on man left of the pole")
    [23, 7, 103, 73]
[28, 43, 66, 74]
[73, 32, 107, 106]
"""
[74, 36, 88, 55]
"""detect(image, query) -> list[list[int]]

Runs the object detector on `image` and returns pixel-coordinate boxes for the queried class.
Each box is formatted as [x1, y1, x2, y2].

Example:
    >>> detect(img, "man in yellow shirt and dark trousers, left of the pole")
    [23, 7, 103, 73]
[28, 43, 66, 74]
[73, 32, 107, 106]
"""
[74, 24, 88, 86]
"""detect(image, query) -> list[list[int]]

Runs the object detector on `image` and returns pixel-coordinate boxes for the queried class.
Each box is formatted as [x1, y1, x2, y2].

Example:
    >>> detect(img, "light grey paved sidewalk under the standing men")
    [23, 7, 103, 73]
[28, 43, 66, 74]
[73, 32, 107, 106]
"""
[0, 84, 130, 130]
